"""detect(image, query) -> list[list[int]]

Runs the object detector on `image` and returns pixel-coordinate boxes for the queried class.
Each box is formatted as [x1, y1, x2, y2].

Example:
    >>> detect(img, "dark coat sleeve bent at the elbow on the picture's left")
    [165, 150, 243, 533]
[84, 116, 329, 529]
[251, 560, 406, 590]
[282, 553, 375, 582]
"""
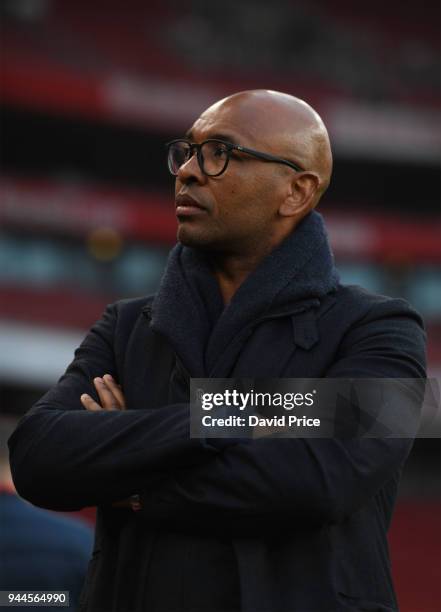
[9, 305, 217, 510]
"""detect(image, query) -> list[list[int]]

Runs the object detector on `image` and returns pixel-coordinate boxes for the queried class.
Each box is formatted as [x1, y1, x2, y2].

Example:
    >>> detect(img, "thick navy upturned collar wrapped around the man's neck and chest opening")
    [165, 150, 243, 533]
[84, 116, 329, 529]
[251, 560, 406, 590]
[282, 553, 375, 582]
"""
[151, 212, 338, 378]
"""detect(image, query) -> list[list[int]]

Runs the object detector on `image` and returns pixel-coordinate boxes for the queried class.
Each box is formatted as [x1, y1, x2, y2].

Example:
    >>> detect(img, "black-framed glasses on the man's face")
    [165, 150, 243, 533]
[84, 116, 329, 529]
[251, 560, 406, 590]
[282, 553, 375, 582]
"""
[165, 138, 303, 176]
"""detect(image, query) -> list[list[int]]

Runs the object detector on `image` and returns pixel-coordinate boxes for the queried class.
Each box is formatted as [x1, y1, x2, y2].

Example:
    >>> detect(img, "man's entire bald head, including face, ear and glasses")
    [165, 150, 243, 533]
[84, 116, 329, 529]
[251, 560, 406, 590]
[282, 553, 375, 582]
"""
[171, 89, 332, 262]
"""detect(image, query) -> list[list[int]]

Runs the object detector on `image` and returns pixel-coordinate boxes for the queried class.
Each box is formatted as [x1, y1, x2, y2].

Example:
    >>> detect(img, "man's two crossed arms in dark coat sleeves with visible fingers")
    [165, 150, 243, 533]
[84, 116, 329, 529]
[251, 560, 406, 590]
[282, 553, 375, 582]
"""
[7, 300, 424, 529]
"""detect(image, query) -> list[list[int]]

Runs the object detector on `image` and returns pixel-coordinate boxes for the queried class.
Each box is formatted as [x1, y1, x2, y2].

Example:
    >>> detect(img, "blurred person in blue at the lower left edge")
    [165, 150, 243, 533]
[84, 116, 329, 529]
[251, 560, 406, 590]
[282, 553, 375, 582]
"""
[0, 414, 93, 611]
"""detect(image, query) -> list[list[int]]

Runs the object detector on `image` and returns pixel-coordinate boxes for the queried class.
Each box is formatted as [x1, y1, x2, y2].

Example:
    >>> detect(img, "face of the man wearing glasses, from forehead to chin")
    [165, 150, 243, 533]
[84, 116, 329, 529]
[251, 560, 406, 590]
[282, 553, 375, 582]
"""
[175, 101, 289, 254]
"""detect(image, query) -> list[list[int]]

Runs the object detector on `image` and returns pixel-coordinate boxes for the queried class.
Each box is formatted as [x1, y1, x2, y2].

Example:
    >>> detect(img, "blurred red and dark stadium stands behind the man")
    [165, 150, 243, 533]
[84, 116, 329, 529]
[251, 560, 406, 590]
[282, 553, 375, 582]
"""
[0, 0, 441, 612]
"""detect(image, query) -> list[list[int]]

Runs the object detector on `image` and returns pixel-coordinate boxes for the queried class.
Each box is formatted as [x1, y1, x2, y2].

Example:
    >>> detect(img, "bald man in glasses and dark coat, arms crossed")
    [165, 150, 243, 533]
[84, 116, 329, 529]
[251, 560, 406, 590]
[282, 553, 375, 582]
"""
[10, 90, 425, 612]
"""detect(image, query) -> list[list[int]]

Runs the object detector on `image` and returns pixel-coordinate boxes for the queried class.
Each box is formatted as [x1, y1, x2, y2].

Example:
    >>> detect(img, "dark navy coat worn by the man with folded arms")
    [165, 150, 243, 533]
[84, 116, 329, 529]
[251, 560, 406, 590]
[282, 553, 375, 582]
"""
[10, 212, 425, 612]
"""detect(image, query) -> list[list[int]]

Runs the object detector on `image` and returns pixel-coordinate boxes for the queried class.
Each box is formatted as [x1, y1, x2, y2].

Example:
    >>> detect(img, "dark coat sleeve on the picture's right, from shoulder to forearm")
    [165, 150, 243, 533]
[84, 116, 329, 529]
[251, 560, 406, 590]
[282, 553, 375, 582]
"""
[135, 301, 425, 532]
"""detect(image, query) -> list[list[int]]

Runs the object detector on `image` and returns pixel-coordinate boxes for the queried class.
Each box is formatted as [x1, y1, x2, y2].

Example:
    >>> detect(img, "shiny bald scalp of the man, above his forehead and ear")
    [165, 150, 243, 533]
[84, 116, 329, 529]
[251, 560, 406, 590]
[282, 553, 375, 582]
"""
[198, 89, 332, 204]
